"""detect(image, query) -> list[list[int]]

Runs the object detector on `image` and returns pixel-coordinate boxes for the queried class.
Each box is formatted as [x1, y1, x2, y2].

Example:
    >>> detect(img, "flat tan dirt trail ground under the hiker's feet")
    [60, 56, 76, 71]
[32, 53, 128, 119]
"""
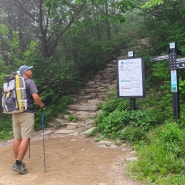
[0, 132, 142, 185]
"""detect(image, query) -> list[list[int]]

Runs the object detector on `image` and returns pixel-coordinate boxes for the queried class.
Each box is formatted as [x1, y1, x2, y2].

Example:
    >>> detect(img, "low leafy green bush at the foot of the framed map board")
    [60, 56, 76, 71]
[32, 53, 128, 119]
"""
[96, 109, 156, 140]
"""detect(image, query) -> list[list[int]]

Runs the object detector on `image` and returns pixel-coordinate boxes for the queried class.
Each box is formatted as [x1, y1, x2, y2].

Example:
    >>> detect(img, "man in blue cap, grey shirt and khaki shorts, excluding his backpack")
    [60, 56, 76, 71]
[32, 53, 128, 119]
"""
[12, 65, 44, 174]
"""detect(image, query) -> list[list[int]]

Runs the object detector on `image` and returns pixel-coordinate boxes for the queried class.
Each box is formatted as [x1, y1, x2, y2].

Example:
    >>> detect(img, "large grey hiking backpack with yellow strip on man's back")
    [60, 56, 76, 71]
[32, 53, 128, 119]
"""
[2, 72, 27, 114]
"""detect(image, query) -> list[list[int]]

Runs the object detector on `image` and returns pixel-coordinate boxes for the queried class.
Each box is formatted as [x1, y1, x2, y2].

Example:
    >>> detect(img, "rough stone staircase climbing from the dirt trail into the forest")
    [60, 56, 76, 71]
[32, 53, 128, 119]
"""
[48, 60, 116, 135]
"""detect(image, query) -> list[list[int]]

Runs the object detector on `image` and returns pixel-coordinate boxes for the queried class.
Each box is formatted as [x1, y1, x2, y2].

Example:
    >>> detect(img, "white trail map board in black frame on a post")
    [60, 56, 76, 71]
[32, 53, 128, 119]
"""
[117, 58, 145, 98]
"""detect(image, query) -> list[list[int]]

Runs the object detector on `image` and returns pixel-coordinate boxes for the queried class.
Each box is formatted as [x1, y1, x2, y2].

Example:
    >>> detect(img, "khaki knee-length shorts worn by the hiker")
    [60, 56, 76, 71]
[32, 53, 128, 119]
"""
[12, 113, 34, 139]
